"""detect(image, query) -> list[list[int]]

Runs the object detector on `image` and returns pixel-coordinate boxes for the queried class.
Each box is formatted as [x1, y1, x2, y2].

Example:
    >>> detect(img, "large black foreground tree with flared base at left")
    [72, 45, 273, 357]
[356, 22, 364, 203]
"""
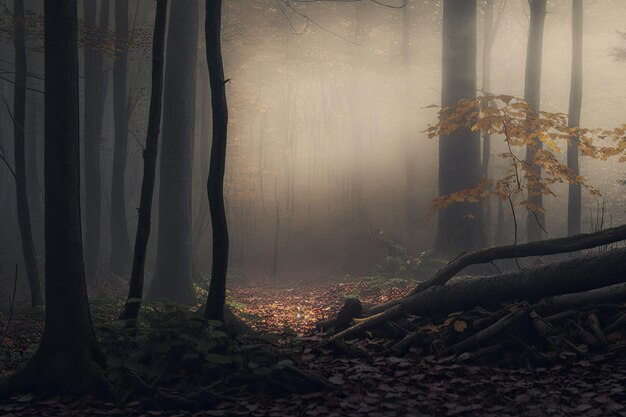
[0, 0, 110, 396]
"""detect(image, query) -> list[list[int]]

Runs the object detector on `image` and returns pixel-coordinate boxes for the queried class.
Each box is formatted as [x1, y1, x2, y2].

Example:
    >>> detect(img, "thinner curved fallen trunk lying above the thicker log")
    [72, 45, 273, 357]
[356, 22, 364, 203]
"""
[411, 225, 626, 295]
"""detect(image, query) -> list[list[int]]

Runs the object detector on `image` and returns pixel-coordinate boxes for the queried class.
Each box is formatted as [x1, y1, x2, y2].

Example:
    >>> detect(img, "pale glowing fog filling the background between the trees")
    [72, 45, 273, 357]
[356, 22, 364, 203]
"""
[0, 0, 626, 294]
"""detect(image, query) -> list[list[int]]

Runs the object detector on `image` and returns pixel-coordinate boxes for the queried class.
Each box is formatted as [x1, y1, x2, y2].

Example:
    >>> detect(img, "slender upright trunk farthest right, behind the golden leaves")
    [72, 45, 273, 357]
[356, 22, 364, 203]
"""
[567, 0, 583, 236]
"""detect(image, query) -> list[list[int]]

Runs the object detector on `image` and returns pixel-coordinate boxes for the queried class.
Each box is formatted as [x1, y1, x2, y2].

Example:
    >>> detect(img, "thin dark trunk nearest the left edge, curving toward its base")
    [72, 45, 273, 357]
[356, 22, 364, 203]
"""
[13, 0, 43, 306]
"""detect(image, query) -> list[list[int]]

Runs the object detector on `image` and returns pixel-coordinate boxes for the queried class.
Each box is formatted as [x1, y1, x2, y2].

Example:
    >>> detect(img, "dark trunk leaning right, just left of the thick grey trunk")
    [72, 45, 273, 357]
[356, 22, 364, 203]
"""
[120, 0, 167, 320]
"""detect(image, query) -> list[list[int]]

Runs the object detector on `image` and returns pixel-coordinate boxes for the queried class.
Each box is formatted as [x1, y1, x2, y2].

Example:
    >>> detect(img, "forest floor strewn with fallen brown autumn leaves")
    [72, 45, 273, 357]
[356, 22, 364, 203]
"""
[0, 277, 626, 417]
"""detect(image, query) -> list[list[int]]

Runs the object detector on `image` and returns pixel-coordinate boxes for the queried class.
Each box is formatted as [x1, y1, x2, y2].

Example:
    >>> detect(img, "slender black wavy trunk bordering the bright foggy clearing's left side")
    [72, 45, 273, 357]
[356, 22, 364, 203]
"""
[205, 0, 228, 321]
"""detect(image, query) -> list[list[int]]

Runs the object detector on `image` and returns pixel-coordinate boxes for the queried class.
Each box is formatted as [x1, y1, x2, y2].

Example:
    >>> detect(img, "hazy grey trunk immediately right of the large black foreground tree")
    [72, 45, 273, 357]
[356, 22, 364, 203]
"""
[84, 0, 109, 280]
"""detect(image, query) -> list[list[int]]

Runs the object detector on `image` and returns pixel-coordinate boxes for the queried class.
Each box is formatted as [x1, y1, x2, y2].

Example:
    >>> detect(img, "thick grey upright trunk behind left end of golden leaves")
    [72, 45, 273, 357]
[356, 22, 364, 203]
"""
[435, 0, 486, 256]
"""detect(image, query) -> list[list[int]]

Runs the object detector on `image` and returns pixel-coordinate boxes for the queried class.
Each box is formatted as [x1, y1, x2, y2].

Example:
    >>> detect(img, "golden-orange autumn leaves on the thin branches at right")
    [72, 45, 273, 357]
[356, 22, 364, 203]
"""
[427, 94, 626, 216]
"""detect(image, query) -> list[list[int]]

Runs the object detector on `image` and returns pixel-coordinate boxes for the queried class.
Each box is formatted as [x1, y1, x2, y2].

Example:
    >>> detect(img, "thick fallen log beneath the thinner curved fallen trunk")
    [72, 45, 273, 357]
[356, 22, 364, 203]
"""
[329, 249, 626, 342]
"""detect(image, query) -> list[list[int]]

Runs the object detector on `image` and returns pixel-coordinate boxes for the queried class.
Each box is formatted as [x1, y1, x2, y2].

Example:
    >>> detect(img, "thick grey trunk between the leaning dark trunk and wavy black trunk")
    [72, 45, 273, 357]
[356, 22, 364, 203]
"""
[148, 0, 199, 303]
